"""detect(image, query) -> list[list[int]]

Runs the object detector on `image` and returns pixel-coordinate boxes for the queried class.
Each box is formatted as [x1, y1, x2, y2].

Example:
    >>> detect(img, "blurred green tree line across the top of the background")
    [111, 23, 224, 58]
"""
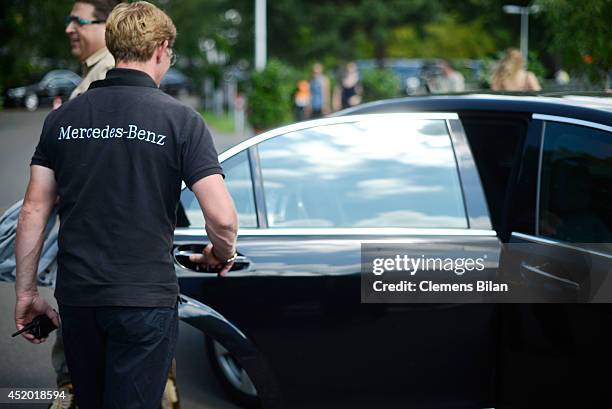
[0, 0, 612, 93]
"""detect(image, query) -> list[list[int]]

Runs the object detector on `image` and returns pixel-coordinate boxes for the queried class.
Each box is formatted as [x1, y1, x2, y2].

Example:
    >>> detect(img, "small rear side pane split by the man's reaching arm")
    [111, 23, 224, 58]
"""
[181, 151, 257, 228]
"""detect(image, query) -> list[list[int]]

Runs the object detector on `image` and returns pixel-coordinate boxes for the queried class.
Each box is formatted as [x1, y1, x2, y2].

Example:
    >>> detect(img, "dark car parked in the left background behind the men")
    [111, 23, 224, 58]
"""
[4, 70, 81, 111]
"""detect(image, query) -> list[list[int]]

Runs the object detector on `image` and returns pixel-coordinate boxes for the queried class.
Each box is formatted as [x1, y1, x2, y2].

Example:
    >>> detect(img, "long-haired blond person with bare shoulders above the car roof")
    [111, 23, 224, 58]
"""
[491, 48, 542, 92]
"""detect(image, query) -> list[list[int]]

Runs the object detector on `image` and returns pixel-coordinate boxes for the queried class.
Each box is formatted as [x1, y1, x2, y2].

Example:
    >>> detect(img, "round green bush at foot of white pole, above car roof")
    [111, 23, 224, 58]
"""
[247, 60, 297, 130]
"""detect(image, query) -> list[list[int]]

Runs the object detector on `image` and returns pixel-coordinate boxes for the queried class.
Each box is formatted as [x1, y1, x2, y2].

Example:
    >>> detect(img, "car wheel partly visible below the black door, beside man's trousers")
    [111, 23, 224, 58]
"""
[206, 337, 261, 408]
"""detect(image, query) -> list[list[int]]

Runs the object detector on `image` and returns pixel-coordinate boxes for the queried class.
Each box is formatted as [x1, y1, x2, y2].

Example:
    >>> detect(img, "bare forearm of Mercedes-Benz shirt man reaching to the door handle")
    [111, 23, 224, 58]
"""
[191, 174, 238, 262]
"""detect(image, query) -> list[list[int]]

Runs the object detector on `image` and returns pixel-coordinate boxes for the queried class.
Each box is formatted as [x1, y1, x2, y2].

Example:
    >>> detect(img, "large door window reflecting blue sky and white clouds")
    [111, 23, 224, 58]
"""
[258, 117, 467, 228]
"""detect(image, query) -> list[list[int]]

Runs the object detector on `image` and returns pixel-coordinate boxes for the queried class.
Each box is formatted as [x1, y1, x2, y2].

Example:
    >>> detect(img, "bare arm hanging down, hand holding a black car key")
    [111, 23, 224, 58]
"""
[15, 165, 59, 344]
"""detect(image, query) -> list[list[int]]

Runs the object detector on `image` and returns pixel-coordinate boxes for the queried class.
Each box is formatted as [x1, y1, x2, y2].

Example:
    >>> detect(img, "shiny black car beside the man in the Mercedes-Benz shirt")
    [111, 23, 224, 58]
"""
[174, 95, 612, 409]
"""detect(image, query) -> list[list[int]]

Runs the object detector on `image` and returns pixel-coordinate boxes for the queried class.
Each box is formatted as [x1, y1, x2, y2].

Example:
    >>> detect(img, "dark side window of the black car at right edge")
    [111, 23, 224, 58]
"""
[539, 122, 612, 244]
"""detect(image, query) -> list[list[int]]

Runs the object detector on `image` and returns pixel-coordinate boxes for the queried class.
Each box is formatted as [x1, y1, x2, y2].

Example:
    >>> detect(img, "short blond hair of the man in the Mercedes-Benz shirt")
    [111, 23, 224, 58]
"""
[106, 1, 176, 62]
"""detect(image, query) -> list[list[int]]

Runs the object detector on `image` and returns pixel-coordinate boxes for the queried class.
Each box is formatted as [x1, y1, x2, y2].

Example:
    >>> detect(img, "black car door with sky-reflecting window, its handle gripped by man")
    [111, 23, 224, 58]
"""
[175, 113, 499, 408]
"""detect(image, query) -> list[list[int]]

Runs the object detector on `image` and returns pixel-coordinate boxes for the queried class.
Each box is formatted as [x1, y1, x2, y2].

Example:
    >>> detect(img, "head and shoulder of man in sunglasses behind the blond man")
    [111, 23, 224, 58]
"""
[66, 0, 122, 98]
